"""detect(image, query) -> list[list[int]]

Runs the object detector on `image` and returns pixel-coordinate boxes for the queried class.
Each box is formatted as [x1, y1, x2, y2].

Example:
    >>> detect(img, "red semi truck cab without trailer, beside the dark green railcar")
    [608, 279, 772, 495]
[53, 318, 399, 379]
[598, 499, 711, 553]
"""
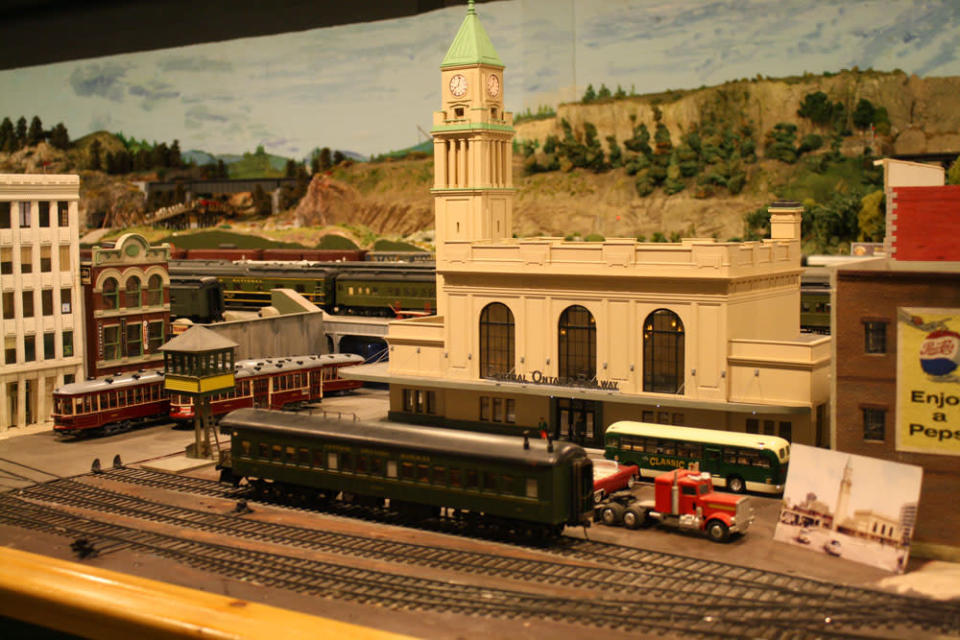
[594, 469, 753, 542]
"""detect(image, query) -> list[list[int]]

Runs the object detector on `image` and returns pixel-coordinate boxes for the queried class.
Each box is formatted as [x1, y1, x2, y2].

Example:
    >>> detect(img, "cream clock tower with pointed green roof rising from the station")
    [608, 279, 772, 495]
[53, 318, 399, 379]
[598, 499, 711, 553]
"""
[431, 0, 514, 288]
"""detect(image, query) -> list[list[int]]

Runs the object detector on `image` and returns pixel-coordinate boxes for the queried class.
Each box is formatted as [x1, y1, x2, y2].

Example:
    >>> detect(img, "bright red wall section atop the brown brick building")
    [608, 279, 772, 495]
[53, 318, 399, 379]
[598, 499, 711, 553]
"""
[890, 185, 960, 261]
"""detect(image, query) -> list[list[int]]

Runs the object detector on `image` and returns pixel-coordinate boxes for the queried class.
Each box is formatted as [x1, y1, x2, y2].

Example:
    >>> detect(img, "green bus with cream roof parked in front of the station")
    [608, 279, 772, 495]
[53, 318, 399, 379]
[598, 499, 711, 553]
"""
[604, 420, 790, 494]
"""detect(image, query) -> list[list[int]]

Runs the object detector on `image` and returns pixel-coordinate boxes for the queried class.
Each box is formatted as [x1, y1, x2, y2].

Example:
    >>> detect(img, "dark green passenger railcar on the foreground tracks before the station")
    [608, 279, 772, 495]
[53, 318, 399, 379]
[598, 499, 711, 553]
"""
[220, 409, 593, 539]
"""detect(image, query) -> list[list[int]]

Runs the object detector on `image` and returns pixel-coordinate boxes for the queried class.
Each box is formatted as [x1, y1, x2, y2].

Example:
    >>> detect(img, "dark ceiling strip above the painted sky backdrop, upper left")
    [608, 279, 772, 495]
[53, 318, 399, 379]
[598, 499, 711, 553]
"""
[0, 0, 496, 69]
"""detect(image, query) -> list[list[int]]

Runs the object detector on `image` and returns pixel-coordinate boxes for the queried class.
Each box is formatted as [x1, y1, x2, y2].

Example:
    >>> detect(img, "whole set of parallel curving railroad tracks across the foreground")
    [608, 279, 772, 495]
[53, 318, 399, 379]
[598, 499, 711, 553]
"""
[0, 461, 960, 638]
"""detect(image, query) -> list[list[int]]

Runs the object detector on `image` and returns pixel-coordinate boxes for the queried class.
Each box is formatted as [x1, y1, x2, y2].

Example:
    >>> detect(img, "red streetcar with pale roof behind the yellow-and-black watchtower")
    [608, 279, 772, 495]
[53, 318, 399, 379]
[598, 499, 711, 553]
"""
[170, 353, 364, 422]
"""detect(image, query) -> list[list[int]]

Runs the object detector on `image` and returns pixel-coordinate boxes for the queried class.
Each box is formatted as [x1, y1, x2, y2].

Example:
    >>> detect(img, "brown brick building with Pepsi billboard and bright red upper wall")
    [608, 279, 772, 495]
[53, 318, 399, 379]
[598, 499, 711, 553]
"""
[832, 168, 960, 556]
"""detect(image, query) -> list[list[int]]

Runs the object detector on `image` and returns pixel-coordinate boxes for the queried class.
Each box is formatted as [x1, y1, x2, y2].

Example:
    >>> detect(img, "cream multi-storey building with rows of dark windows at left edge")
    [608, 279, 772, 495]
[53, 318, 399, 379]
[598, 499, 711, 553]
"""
[0, 174, 83, 437]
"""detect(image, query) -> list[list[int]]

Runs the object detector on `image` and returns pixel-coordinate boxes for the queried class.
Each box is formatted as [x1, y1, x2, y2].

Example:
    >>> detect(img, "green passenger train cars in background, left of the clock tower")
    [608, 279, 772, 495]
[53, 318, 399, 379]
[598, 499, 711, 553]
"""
[169, 254, 437, 317]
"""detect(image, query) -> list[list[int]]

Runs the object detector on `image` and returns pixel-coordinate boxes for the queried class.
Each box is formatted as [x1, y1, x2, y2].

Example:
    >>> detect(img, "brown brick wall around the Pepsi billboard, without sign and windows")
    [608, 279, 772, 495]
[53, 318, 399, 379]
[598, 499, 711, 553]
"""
[833, 269, 960, 546]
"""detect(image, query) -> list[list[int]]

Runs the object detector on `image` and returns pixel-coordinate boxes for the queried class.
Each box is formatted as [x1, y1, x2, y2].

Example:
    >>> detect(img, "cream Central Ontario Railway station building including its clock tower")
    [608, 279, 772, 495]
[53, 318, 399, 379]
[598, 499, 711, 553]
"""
[352, 3, 831, 446]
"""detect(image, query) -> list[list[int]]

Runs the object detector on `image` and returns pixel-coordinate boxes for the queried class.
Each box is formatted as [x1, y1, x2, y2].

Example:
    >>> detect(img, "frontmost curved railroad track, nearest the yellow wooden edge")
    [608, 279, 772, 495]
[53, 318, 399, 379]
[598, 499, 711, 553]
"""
[0, 494, 944, 640]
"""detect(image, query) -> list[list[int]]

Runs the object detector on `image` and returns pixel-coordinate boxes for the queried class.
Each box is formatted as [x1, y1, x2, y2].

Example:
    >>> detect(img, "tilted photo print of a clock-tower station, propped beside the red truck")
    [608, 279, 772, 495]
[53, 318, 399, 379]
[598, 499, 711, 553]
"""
[774, 444, 923, 573]
